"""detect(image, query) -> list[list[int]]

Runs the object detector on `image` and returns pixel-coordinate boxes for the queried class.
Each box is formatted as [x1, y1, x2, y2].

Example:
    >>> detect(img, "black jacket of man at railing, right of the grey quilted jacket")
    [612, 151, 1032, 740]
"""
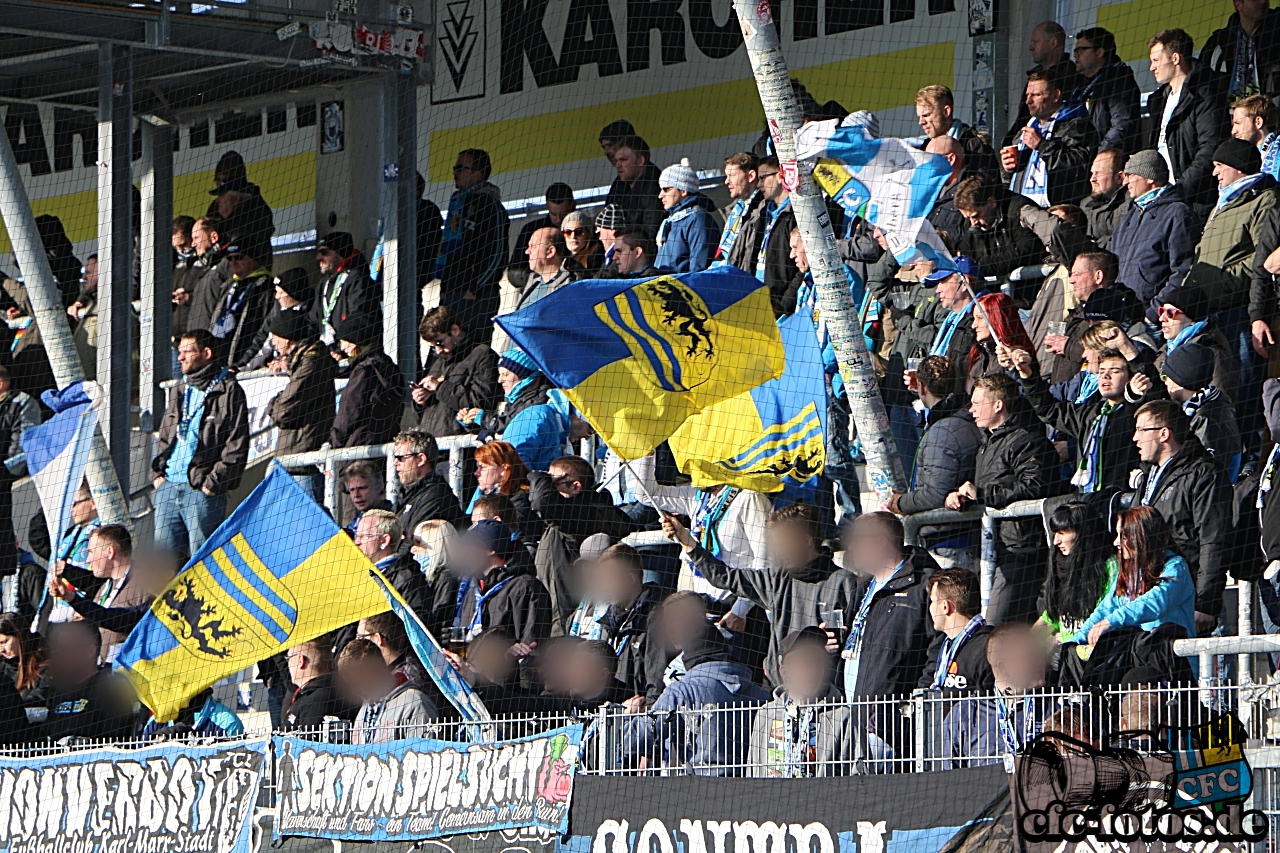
[973, 405, 1054, 553]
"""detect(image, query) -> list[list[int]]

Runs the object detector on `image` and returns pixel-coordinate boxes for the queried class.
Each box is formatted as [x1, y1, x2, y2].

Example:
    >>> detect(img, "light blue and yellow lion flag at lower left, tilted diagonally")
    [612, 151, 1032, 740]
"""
[115, 465, 388, 721]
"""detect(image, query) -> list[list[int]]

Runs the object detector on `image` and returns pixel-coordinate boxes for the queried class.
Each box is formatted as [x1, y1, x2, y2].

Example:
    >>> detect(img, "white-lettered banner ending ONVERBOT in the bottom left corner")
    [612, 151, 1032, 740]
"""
[0, 739, 266, 853]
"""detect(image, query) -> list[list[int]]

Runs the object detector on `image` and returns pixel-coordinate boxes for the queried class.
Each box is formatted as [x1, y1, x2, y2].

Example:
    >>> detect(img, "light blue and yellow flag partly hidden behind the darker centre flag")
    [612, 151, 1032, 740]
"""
[671, 310, 827, 492]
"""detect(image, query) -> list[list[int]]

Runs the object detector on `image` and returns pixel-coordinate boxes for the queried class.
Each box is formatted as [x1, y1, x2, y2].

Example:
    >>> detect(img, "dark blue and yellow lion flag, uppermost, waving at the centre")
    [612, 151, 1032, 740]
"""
[497, 266, 785, 460]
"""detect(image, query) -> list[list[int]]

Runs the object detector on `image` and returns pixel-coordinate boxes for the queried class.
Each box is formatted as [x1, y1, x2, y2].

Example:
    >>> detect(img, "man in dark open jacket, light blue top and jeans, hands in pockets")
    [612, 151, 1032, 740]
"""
[151, 329, 248, 556]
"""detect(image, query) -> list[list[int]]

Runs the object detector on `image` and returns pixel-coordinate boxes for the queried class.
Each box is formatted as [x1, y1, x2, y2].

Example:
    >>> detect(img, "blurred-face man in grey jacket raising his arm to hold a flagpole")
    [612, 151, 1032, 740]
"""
[662, 503, 858, 684]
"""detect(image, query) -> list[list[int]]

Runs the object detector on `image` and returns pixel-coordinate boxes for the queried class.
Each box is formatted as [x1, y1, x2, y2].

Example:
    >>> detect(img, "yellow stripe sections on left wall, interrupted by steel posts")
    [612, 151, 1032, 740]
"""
[0, 151, 316, 253]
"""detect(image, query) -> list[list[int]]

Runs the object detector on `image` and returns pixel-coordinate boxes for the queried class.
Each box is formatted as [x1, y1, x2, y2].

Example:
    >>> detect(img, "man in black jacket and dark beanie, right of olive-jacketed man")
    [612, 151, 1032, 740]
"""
[329, 308, 404, 448]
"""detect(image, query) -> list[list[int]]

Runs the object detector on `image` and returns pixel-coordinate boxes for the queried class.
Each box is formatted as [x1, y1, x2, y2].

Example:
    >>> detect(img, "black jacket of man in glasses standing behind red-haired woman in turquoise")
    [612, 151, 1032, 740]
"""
[1133, 435, 1233, 616]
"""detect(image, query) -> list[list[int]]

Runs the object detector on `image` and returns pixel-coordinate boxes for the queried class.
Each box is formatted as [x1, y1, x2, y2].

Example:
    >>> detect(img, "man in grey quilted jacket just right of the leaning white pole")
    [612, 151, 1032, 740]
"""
[888, 356, 982, 569]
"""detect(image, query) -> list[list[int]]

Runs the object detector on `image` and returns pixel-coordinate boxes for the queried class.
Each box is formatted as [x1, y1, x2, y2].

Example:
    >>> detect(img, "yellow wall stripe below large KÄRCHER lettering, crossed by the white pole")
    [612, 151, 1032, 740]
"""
[429, 41, 955, 182]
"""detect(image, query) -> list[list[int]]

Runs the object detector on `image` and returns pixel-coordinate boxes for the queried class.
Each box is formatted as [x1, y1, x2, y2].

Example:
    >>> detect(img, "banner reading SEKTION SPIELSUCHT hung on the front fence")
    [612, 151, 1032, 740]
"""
[275, 725, 582, 841]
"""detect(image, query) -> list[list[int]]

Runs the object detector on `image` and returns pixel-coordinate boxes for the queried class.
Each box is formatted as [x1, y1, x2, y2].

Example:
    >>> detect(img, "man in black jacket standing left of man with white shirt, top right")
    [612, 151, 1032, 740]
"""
[1071, 27, 1142, 154]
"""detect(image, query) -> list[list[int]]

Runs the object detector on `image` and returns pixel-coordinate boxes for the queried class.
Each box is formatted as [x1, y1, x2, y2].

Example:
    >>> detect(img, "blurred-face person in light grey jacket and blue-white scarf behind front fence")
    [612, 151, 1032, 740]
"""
[746, 626, 856, 779]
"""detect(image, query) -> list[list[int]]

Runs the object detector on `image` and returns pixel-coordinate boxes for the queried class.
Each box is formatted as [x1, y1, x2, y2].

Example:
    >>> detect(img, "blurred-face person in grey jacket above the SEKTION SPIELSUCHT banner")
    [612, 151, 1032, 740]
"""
[338, 637, 435, 745]
